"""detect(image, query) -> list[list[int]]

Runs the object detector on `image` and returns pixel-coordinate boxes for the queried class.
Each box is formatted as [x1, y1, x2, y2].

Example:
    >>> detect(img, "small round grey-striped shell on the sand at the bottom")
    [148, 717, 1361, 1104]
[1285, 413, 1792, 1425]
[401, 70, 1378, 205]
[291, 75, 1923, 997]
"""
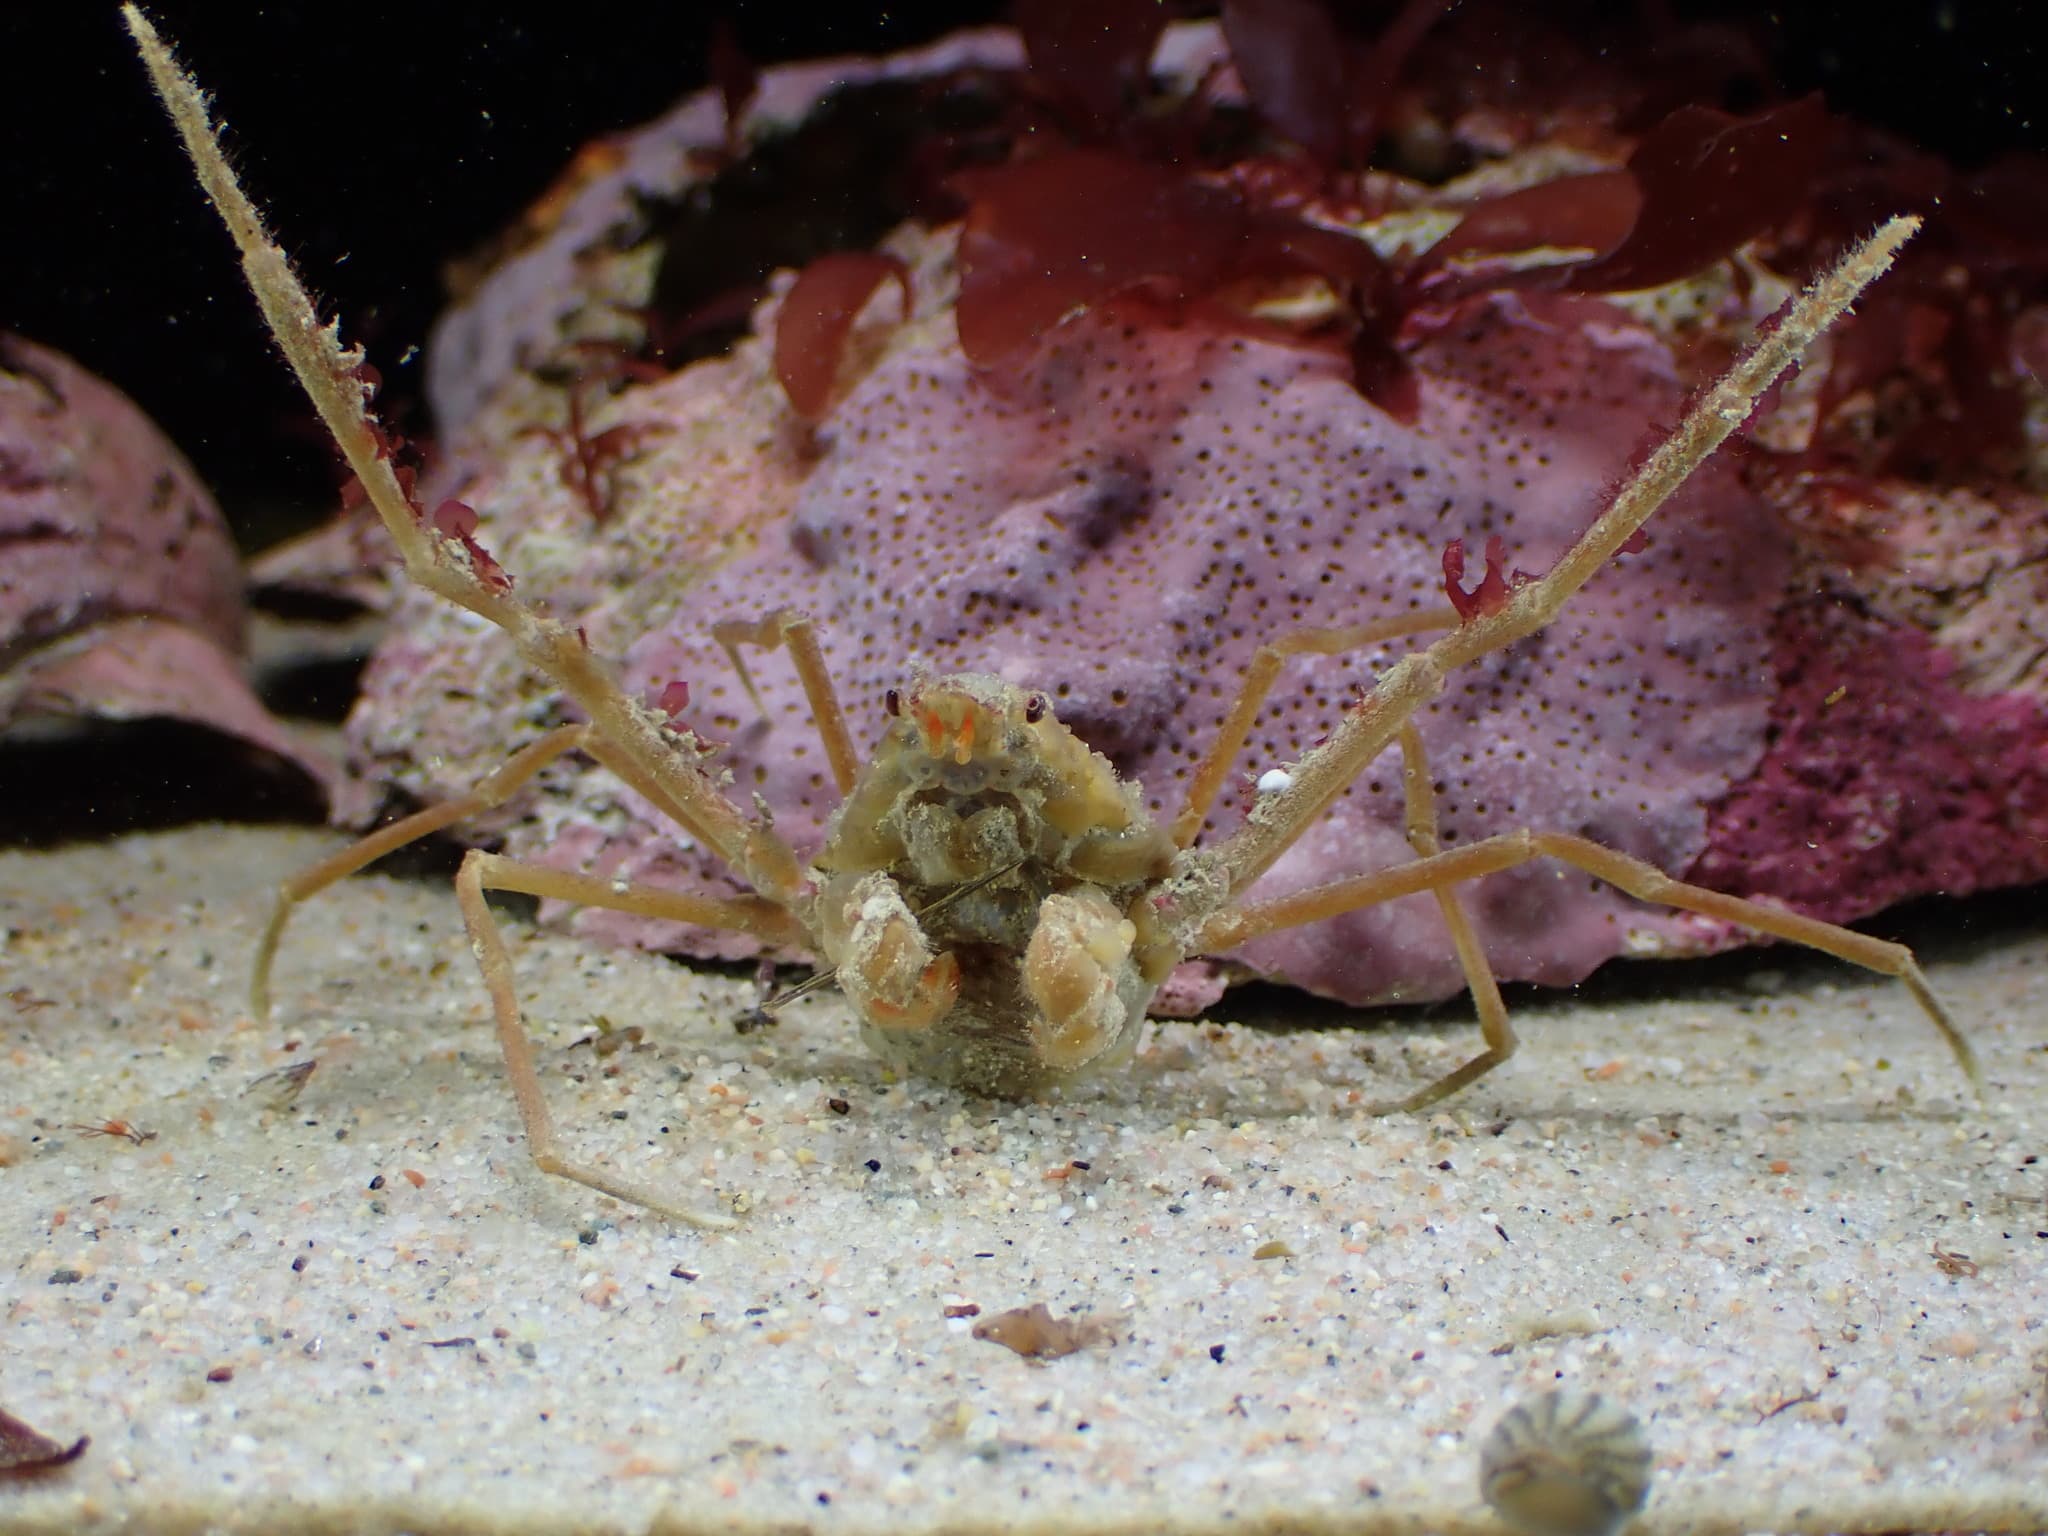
[1479, 1391, 1651, 1536]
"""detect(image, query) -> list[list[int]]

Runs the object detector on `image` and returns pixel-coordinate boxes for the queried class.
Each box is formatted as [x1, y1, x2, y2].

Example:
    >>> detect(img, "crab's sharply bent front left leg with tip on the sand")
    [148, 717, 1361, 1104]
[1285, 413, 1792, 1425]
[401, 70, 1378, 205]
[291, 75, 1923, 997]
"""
[455, 850, 803, 1227]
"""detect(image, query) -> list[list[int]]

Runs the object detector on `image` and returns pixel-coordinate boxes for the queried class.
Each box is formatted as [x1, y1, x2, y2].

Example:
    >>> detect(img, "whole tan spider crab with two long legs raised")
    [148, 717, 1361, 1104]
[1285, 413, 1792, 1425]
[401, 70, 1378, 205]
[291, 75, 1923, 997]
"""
[125, 6, 1976, 1227]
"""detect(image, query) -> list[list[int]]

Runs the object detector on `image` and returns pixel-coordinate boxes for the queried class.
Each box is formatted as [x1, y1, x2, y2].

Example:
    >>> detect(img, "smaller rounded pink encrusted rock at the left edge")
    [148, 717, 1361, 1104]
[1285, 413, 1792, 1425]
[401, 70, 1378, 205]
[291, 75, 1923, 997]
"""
[0, 336, 362, 813]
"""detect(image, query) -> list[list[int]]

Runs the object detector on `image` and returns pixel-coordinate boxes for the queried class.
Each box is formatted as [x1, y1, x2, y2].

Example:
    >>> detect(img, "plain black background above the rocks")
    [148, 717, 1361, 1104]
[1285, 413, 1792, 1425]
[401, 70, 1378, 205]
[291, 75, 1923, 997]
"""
[0, 0, 2048, 544]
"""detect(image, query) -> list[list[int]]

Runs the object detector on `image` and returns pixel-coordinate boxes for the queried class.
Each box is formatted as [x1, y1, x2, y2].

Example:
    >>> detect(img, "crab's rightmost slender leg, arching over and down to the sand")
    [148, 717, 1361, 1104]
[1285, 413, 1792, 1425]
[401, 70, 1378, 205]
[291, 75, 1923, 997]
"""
[1198, 831, 1985, 1108]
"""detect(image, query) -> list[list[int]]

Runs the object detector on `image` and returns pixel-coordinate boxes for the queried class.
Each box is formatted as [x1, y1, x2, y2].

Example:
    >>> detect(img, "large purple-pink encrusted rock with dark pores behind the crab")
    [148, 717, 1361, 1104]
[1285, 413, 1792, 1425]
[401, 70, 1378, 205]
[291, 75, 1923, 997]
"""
[331, 31, 2048, 1006]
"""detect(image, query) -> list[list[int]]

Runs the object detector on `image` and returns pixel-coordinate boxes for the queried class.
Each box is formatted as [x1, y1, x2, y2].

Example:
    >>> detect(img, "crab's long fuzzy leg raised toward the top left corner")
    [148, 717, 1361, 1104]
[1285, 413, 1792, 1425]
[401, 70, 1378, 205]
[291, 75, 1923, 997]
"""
[121, 4, 803, 899]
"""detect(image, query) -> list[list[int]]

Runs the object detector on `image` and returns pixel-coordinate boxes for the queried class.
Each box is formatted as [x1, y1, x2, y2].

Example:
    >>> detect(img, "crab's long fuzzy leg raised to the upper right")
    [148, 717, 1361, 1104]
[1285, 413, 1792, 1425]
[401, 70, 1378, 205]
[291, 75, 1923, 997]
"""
[1214, 217, 1919, 893]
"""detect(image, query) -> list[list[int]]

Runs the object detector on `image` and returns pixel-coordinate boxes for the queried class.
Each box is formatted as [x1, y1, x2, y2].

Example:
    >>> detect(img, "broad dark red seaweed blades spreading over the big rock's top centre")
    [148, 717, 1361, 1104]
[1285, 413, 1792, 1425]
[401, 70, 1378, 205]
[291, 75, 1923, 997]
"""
[958, 83, 1859, 420]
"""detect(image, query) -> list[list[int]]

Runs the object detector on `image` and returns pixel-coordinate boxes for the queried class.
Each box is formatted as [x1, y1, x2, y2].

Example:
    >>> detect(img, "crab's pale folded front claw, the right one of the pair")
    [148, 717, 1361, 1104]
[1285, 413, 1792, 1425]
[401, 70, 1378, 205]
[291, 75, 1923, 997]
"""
[1024, 885, 1139, 1073]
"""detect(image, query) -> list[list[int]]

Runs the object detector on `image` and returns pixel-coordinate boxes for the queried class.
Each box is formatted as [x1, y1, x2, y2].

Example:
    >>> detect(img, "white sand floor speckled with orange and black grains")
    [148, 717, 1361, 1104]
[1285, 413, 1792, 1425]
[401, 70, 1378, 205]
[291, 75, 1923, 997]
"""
[0, 827, 2048, 1532]
